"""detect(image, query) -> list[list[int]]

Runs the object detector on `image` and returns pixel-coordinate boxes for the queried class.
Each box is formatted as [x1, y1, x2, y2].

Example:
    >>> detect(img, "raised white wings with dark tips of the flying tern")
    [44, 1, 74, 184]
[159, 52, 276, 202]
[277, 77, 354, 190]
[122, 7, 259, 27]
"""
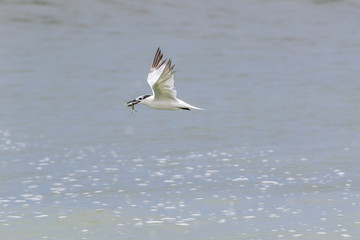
[147, 48, 176, 99]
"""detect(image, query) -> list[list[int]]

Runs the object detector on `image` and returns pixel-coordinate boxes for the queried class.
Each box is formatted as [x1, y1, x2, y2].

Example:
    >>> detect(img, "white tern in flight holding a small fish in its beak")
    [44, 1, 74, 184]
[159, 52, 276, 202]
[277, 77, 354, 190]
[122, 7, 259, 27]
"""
[126, 48, 204, 111]
